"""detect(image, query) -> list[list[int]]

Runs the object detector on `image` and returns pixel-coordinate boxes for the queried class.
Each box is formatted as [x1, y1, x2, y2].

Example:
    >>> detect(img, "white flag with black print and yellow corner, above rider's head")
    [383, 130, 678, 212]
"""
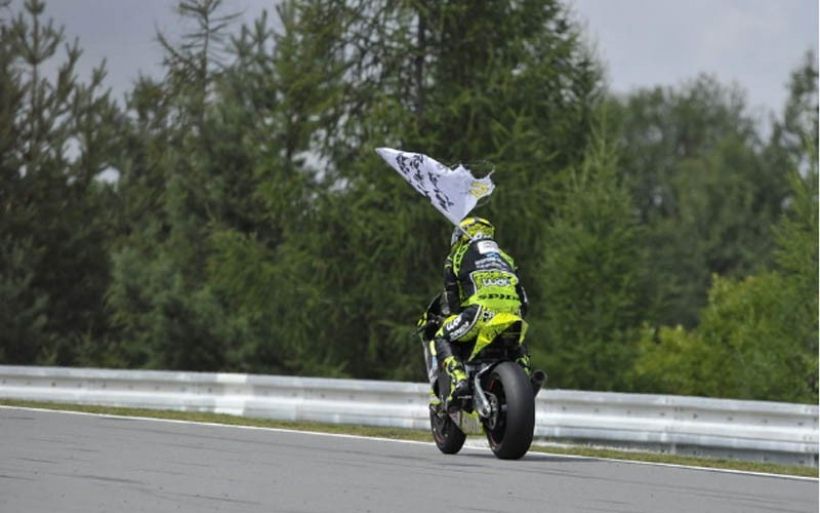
[376, 148, 495, 226]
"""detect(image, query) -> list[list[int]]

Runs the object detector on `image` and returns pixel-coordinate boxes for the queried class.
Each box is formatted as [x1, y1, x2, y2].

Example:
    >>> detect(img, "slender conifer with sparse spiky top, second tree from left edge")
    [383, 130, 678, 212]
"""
[108, 0, 243, 370]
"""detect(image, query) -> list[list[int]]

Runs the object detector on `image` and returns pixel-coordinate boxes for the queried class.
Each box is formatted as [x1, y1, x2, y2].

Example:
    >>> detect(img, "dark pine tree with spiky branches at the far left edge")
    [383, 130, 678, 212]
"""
[0, 0, 119, 364]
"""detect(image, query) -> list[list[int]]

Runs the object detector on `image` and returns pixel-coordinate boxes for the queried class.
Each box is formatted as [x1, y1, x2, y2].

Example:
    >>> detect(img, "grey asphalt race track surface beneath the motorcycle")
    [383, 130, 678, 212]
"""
[0, 408, 818, 513]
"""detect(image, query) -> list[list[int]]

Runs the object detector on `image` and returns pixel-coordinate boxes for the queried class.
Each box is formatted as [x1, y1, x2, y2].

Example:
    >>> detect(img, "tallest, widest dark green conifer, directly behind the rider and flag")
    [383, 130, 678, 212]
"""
[256, 1, 599, 379]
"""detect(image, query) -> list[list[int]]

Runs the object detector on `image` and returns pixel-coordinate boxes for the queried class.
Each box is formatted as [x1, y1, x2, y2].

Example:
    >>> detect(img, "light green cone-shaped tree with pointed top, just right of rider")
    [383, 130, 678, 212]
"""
[531, 117, 645, 390]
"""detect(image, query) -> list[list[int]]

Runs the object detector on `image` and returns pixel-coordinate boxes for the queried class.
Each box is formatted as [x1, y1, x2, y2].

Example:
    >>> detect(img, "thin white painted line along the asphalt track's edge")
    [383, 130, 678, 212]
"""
[0, 405, 818, 481]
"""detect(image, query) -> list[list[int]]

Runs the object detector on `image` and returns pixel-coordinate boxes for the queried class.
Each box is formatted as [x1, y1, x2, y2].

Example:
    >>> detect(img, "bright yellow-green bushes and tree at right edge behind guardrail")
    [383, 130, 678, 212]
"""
[634, 55, 820, 403]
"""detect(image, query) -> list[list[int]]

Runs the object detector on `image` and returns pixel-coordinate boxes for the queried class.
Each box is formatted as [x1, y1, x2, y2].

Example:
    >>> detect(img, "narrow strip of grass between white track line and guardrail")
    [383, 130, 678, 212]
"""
[0, 399, 818, 478]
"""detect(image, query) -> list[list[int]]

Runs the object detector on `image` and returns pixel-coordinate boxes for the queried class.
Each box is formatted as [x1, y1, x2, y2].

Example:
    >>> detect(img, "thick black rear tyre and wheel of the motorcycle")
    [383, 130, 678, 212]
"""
[484, 362, 535, 460]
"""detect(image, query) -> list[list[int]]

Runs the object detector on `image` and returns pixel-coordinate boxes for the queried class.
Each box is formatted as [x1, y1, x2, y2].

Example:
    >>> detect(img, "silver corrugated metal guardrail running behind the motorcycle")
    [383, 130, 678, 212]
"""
[0, 366, 818, 466]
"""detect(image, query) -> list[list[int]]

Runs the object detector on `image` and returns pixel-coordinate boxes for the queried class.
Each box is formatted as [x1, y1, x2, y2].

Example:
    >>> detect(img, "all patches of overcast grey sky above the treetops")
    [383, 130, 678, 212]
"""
[12, 0, 818, 118]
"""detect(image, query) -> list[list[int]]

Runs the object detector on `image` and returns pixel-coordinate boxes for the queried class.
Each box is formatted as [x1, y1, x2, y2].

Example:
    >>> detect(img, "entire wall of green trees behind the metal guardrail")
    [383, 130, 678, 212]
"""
[0, 0, 818, 402]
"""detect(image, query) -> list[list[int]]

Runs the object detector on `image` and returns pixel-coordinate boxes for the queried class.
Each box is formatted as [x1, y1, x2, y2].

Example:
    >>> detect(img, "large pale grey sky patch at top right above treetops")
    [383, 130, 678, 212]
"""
[572, 0, 818, 116]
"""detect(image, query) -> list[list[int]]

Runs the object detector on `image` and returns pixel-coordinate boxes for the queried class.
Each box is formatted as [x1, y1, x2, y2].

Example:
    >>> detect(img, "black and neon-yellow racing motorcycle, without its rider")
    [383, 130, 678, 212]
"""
[418, 294, 547, 459]
